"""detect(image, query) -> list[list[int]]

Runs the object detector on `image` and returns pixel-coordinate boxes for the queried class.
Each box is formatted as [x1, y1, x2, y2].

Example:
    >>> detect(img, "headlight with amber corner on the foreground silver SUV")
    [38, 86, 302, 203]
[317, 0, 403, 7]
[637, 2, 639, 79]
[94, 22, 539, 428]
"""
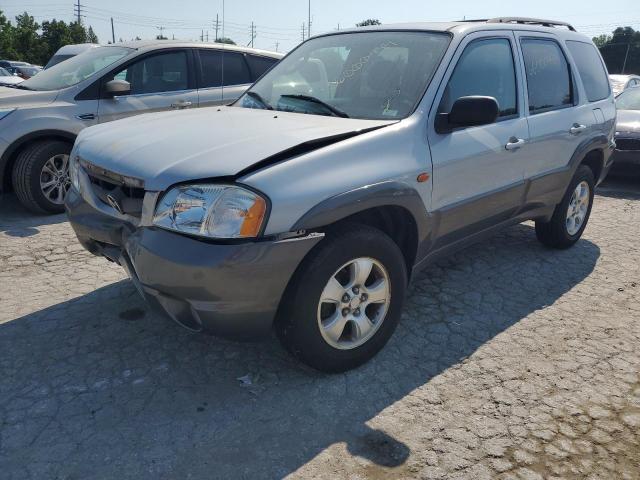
[153, 184, 267, 238]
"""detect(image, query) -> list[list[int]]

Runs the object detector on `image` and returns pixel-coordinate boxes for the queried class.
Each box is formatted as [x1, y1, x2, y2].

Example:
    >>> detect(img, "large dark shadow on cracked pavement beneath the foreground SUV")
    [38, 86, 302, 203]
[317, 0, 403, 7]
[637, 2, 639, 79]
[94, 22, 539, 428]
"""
[0, 225, 600, 479]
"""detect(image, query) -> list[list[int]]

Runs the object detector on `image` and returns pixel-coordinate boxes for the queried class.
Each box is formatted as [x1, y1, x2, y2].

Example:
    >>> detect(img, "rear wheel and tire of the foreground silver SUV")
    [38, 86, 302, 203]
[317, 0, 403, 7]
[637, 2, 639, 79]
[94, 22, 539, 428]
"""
[536, 165, 595, 249]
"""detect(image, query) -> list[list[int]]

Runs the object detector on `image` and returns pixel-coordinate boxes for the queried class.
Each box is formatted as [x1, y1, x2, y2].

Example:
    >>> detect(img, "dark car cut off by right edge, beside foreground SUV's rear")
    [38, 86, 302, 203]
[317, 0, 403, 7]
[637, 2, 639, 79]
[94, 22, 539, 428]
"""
[613, 87, 640, 174]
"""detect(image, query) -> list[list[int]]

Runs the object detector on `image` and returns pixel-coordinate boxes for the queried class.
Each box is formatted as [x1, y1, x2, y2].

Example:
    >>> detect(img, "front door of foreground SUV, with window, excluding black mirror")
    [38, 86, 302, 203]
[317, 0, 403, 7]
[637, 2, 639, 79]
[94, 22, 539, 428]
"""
[429, 31, 529, 242]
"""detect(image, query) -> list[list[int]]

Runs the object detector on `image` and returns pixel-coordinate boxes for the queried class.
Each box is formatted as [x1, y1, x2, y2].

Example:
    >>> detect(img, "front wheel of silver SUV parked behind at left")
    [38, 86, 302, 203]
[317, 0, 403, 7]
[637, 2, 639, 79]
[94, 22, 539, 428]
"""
[12, 140, 71, 213]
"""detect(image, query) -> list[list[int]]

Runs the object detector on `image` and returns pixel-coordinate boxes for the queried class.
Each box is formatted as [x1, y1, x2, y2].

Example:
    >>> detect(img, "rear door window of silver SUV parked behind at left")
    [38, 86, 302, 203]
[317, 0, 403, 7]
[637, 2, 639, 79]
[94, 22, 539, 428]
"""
[200, 50, 251, 88]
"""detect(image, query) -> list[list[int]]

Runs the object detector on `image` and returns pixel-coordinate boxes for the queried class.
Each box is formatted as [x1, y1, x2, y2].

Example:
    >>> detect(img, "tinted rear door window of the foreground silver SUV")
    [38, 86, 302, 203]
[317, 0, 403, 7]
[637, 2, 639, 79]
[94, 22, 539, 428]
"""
[521, 39, 573, 113]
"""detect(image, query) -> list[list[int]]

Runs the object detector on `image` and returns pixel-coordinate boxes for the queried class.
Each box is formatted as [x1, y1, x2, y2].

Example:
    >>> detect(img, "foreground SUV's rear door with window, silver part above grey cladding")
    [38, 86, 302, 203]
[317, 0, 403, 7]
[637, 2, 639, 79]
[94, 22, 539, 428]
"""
[515, 31, 597, 179]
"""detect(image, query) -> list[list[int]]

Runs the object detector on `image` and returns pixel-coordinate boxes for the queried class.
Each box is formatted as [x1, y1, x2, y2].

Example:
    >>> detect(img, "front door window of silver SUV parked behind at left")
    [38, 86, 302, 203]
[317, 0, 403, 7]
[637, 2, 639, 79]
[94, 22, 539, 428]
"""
[114, 52, 189, 95]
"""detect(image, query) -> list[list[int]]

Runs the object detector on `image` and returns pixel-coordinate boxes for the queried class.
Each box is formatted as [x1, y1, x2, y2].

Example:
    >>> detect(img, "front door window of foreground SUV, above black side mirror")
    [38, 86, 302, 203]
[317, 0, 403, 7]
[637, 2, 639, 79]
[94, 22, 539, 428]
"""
[438, 38, 518, 117]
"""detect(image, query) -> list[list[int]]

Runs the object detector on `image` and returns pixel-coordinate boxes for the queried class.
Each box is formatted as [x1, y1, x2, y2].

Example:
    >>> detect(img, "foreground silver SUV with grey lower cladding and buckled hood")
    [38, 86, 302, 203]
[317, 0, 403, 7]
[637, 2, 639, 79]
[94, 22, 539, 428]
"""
[67, 18, 616, 371]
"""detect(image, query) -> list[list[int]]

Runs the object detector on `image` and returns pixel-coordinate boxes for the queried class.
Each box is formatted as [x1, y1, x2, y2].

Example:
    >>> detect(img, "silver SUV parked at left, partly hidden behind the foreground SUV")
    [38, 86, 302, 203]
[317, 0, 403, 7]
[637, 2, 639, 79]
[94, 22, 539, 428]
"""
[0, 41, 282, 213]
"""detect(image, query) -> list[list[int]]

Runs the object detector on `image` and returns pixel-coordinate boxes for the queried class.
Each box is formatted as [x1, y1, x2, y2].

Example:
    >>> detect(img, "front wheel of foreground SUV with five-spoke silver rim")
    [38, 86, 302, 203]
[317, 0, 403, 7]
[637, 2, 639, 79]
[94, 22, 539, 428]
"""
[276, 224, 407, 373]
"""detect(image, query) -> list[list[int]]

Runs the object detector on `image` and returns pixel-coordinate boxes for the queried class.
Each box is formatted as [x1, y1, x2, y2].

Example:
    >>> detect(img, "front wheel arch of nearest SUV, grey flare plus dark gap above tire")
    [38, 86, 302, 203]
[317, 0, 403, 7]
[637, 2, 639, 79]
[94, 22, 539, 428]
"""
[292, 181, 430, 275]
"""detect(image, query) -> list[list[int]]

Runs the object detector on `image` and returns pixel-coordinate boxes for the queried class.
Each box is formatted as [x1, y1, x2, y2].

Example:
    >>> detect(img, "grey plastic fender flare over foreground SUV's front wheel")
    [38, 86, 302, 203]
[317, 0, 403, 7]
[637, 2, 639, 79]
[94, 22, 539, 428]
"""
[292, 180, 432, 260]
